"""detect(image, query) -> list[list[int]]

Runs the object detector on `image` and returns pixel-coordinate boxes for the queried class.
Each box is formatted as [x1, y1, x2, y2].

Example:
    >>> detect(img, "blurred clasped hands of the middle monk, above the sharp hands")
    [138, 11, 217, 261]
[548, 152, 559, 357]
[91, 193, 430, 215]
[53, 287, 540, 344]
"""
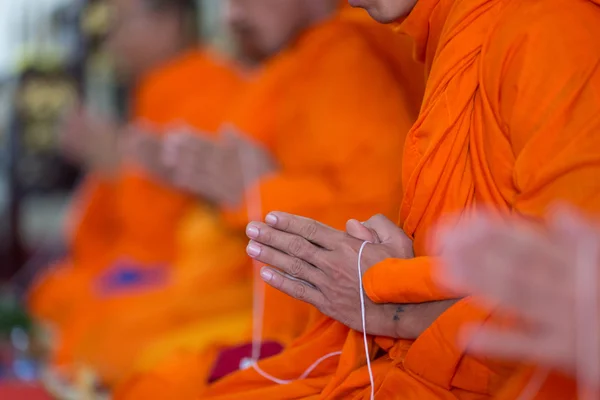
[163, 126, 276, 207]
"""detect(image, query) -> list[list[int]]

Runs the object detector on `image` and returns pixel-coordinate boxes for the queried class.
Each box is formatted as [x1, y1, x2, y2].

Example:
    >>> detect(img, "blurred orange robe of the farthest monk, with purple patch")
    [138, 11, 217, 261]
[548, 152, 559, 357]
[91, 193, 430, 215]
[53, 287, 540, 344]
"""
[29, 50, 251, 384]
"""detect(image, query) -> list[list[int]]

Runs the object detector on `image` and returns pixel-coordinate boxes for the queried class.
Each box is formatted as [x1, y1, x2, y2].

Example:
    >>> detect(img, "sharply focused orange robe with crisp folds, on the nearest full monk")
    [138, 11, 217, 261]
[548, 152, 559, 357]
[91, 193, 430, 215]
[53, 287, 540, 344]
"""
[202, 0, 600, 400]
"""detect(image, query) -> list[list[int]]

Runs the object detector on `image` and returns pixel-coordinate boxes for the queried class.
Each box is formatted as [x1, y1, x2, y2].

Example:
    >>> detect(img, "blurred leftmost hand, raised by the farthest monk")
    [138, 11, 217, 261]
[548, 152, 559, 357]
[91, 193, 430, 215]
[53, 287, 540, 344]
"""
[59, 107, 122, 177]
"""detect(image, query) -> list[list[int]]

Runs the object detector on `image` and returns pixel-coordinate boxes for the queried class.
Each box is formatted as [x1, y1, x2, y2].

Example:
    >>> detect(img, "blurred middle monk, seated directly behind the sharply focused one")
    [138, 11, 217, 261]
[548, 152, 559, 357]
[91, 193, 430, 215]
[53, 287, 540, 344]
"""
[115, 0, 423, 399]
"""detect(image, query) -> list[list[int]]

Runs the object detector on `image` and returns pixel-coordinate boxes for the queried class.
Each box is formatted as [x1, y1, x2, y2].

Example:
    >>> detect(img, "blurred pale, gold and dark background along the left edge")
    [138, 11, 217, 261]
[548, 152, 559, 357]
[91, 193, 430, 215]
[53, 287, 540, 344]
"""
[0, 0, 229, 399]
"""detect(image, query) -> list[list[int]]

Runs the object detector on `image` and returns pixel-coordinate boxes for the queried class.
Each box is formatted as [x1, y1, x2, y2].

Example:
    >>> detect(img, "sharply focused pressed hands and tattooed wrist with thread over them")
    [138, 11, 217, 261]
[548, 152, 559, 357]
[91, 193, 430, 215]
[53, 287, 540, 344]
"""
[246, 213, 454, 339]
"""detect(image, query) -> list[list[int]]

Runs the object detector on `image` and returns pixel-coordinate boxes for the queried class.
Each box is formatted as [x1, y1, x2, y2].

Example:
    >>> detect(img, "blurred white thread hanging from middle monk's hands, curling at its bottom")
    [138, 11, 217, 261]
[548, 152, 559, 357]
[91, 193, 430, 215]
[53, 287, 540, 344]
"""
[238, 130, 342, 385]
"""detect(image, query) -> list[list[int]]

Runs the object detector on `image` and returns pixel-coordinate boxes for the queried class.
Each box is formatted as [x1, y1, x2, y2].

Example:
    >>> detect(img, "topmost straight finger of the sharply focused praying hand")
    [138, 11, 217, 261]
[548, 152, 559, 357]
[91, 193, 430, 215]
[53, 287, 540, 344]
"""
[265, 212, 345, 250]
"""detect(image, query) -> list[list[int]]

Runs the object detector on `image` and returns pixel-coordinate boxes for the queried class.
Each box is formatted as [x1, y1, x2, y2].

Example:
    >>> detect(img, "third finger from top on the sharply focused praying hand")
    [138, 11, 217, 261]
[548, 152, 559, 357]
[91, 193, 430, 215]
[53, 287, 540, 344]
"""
[246, 240, 325, 288]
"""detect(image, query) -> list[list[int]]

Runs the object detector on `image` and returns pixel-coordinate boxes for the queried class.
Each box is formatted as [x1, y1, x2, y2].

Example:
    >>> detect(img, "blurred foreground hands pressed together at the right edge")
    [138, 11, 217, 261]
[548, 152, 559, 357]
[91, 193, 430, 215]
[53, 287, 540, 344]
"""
[438, 208, 600, 399]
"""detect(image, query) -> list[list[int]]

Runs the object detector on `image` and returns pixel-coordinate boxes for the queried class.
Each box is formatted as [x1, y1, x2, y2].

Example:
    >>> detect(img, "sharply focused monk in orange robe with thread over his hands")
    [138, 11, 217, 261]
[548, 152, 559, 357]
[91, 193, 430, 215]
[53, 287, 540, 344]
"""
[203, 0, 600, 399]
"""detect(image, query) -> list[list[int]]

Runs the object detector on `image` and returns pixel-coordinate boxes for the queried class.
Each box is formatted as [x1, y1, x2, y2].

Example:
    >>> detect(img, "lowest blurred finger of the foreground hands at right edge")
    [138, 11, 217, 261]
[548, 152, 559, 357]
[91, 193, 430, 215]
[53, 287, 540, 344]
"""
[461, 327, 560, 366]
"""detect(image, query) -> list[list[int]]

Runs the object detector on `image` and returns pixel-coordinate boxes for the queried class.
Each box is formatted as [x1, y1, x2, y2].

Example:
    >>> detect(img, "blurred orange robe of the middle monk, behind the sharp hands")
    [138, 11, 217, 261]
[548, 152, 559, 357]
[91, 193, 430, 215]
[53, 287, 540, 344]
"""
[115, 8, 423, 400]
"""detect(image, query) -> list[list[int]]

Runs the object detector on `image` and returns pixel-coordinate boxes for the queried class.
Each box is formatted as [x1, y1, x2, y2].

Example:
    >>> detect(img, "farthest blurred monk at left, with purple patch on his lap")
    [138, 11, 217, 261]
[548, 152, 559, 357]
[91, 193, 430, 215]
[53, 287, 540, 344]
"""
[29, 0, 246, 386]
